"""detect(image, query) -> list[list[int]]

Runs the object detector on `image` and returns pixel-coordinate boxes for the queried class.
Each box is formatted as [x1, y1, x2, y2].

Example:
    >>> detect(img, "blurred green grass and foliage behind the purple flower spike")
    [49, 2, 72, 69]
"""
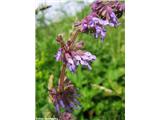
[36, 4, 125, 120]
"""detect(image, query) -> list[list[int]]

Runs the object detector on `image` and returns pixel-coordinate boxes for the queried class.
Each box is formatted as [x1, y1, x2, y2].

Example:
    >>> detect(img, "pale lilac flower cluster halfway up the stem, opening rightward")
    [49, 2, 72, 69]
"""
[55, 36, 96, 72]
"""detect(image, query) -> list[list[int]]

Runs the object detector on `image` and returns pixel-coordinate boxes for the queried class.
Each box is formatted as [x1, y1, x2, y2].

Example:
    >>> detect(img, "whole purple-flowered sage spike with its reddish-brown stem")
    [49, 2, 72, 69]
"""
[49, 0, 125, 120]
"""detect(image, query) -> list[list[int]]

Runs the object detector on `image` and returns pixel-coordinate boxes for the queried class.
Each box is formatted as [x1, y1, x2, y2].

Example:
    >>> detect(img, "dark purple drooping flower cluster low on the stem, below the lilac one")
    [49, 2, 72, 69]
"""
[49, 78, 80, 113]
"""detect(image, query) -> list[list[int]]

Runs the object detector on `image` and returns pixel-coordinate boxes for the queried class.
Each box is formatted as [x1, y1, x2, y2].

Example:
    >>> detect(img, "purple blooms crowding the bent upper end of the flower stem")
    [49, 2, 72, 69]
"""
[75, 0, 124, 41]
